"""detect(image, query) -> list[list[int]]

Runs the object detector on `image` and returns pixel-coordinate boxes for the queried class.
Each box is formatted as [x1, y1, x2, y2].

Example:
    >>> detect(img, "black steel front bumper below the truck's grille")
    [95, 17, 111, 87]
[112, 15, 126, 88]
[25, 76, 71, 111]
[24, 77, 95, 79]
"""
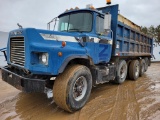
[1, 67, 46, 93]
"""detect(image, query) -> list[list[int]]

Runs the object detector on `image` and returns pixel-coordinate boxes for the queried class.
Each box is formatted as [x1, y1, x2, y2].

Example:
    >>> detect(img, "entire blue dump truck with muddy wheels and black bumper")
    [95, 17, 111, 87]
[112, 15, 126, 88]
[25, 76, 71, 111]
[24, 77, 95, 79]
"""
[1, 5, 153, 112]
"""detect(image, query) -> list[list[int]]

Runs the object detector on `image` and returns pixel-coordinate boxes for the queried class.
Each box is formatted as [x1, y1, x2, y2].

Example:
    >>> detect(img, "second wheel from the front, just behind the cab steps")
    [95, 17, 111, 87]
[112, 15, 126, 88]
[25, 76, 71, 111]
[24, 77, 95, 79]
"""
[114, 60, 127, 84]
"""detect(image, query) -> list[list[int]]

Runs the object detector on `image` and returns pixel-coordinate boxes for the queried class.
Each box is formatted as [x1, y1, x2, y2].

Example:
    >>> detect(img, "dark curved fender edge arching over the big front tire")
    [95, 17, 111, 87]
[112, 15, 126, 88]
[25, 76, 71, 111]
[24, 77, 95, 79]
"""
[58, 55, 89, 73]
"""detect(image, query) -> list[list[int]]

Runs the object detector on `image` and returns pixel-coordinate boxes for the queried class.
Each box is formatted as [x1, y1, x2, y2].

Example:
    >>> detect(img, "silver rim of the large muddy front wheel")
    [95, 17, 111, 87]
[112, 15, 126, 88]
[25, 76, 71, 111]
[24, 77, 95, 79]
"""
[73, 76, 87, 101]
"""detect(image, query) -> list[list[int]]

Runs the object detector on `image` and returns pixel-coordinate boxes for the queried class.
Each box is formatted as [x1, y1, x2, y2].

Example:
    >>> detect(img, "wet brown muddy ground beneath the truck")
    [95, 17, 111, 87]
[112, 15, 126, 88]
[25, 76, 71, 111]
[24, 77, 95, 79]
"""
[0, 63, 160, 120]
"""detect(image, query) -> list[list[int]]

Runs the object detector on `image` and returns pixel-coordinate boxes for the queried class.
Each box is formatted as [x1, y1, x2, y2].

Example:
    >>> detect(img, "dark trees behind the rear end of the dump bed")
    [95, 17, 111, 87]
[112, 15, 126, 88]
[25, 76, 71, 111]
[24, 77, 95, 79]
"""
[141, 25, 160, 43]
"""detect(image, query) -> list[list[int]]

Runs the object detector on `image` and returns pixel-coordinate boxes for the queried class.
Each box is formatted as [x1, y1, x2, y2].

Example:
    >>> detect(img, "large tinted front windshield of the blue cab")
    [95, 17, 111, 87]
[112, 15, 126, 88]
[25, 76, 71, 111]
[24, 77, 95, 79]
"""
[58, 12, 92, 32]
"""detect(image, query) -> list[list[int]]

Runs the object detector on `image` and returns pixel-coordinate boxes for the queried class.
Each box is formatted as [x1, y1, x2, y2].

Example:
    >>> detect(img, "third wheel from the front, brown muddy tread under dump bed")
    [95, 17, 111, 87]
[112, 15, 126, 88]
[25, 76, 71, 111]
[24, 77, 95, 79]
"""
[129, 60, 140, 80]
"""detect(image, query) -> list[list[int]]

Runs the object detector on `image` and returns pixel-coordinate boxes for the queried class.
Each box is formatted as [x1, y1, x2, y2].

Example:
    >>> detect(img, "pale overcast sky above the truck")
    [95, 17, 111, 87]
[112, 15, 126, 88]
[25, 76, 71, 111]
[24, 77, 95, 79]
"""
[0, 0, 160, 32]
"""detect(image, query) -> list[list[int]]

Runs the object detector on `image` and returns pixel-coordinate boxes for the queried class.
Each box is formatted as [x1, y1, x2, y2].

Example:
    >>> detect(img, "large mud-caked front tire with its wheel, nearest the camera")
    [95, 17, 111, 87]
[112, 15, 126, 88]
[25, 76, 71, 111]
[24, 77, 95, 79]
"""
[53, 65, 92, 112]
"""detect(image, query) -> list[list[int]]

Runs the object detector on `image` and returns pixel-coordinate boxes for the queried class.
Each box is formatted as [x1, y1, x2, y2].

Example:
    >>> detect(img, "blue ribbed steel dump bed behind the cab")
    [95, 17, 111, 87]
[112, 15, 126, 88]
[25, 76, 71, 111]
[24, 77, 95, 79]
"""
[98, 5, 153, 56]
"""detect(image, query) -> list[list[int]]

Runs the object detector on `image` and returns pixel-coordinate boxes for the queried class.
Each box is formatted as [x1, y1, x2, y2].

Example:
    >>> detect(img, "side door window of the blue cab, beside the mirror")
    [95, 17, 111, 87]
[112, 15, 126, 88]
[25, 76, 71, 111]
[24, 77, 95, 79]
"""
[96, 16, 104, 34]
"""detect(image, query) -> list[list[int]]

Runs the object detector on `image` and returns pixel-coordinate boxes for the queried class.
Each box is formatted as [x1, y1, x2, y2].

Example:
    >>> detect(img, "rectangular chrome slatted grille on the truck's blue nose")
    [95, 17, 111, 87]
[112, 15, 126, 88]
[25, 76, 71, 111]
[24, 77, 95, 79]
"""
[10, 37, 25, 66]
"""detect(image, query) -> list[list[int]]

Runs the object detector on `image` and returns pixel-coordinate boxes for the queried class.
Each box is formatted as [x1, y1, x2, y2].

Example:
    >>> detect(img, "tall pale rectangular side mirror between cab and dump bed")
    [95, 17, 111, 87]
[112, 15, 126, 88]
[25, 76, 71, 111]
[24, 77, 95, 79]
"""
[104, 14, 111, 32]
